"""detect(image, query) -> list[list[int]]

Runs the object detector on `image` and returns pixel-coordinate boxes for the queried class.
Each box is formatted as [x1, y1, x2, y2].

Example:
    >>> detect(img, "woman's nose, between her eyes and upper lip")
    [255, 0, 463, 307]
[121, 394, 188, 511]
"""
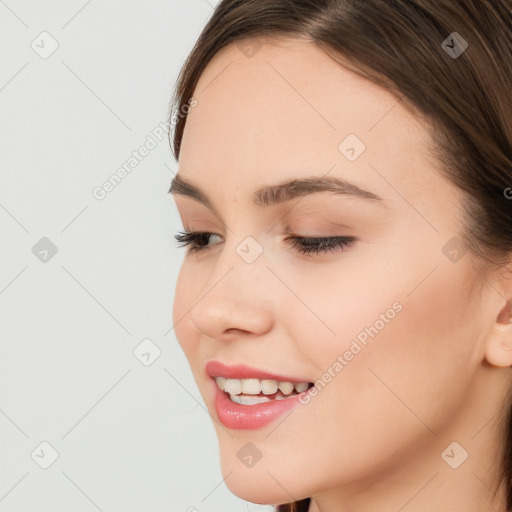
[190, 245, 274, 341]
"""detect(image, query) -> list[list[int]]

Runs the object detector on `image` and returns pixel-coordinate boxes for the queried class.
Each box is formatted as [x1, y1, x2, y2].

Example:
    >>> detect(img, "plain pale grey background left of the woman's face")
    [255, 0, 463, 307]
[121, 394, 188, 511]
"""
[0, 0, 272, 512]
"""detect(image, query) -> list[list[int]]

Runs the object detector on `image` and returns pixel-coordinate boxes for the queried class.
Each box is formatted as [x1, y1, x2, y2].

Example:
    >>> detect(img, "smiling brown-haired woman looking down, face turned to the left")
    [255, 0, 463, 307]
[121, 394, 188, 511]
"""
[170, 0, 512, 512]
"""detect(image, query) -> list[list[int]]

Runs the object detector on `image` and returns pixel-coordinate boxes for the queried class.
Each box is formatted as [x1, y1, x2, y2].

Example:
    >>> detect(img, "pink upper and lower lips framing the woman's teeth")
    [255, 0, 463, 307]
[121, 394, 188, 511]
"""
[206, 361, 308, 430]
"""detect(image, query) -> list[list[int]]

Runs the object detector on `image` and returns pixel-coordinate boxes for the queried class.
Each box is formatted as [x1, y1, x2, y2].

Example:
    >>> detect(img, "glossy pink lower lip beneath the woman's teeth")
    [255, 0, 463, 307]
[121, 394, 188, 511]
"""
[212, 379, 307, 430]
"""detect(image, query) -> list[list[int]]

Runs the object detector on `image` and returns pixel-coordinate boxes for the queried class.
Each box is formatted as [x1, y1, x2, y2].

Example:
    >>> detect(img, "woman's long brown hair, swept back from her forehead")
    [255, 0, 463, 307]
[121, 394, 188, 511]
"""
[170, 0, 512, 512]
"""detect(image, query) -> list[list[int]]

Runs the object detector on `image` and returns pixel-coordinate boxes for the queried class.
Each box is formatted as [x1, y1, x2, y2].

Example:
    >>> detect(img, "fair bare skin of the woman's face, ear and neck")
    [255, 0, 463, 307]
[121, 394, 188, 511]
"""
[173, 38, 512, 512]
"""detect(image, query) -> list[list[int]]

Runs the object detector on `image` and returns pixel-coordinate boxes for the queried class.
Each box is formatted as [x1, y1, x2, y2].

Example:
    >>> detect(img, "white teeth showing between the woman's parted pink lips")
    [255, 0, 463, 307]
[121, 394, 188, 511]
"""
[214, 376, 314, 405]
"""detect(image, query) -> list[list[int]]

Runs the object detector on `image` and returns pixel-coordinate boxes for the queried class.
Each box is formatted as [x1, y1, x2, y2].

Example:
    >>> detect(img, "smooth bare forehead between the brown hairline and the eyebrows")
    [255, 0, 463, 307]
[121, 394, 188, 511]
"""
[180, 38, 438, 199]
